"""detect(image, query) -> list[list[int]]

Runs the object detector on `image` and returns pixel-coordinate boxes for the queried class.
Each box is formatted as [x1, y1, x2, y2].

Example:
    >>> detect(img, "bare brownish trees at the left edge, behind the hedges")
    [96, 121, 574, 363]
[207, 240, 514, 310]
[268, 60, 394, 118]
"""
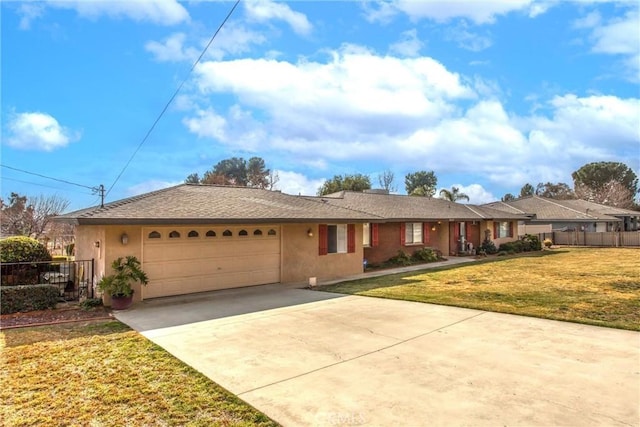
[0, 193, 69, 239]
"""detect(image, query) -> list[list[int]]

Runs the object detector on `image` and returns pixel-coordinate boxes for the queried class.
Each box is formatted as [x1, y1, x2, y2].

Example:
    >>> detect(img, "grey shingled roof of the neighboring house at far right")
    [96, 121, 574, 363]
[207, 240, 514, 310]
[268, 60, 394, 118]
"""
[483, 196, 640, 222]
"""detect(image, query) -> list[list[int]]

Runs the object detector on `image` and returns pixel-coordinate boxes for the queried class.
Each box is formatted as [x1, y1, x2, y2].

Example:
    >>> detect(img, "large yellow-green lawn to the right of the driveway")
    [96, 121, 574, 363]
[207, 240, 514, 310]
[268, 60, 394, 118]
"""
[321, 248, 640, 331]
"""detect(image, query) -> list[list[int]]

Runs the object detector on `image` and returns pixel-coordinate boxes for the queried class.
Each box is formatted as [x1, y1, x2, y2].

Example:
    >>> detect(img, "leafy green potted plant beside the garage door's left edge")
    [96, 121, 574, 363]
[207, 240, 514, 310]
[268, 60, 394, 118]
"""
[98, 256, 149, 310]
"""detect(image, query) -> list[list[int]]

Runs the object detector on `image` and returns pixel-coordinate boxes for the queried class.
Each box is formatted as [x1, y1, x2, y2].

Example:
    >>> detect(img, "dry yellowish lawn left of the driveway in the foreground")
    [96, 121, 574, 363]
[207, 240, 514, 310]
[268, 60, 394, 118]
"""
[0, 321, 277, 426]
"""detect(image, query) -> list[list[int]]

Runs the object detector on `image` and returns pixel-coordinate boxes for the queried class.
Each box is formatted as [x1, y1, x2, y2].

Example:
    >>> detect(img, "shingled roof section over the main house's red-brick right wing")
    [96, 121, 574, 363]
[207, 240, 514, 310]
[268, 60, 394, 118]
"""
[320, 191, 526, 221]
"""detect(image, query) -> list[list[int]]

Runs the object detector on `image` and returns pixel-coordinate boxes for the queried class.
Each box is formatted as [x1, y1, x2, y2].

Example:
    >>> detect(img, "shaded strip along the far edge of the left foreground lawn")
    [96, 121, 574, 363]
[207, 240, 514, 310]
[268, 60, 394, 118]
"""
[0, 320, 131, 348]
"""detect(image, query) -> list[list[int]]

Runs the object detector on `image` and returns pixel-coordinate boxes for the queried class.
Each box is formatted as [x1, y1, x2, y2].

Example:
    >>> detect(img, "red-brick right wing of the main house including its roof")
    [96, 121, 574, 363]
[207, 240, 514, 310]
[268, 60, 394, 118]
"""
[322, 191, 523, 263]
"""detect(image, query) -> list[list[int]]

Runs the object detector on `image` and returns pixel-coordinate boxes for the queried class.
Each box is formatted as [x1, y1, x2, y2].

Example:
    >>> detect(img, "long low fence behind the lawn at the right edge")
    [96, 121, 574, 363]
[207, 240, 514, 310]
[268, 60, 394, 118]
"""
[539, 231, 640, 247]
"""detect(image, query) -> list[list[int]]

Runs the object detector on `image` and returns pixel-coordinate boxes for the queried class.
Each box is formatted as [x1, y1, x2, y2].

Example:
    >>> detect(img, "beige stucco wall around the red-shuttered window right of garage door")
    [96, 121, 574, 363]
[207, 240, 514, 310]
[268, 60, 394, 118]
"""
[281, 224, 363, 283]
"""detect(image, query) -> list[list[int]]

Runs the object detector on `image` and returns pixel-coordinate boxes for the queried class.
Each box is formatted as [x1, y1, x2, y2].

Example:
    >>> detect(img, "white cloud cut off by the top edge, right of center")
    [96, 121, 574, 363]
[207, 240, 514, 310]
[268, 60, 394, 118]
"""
[365, 0, 536, 24]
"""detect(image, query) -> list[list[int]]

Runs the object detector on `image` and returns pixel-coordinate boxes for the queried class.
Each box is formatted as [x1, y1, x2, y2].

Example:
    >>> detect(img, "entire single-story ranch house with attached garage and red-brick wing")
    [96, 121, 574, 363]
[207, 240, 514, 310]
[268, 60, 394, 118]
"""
[56, 184, 522, 303]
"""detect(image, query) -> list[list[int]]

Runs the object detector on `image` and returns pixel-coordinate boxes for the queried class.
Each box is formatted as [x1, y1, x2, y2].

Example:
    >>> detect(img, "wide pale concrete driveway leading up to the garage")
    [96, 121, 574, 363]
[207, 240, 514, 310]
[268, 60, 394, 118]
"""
[116, 285, 640, 426]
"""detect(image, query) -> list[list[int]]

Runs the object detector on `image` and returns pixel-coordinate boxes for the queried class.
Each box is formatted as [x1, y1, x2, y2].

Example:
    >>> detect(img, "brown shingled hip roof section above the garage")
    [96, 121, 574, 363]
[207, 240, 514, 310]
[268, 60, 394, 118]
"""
[56, 184, 380, 224]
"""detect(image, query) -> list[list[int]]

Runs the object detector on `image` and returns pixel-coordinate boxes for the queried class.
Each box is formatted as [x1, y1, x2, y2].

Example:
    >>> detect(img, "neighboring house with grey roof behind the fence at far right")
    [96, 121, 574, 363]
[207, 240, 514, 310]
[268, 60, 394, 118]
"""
[483, 196, 640, 235]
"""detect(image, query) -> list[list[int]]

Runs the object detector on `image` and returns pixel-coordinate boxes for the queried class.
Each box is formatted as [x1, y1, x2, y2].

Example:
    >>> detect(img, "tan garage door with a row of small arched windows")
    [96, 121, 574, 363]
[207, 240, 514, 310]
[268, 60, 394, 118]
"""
[142, 226, 280, 299]
